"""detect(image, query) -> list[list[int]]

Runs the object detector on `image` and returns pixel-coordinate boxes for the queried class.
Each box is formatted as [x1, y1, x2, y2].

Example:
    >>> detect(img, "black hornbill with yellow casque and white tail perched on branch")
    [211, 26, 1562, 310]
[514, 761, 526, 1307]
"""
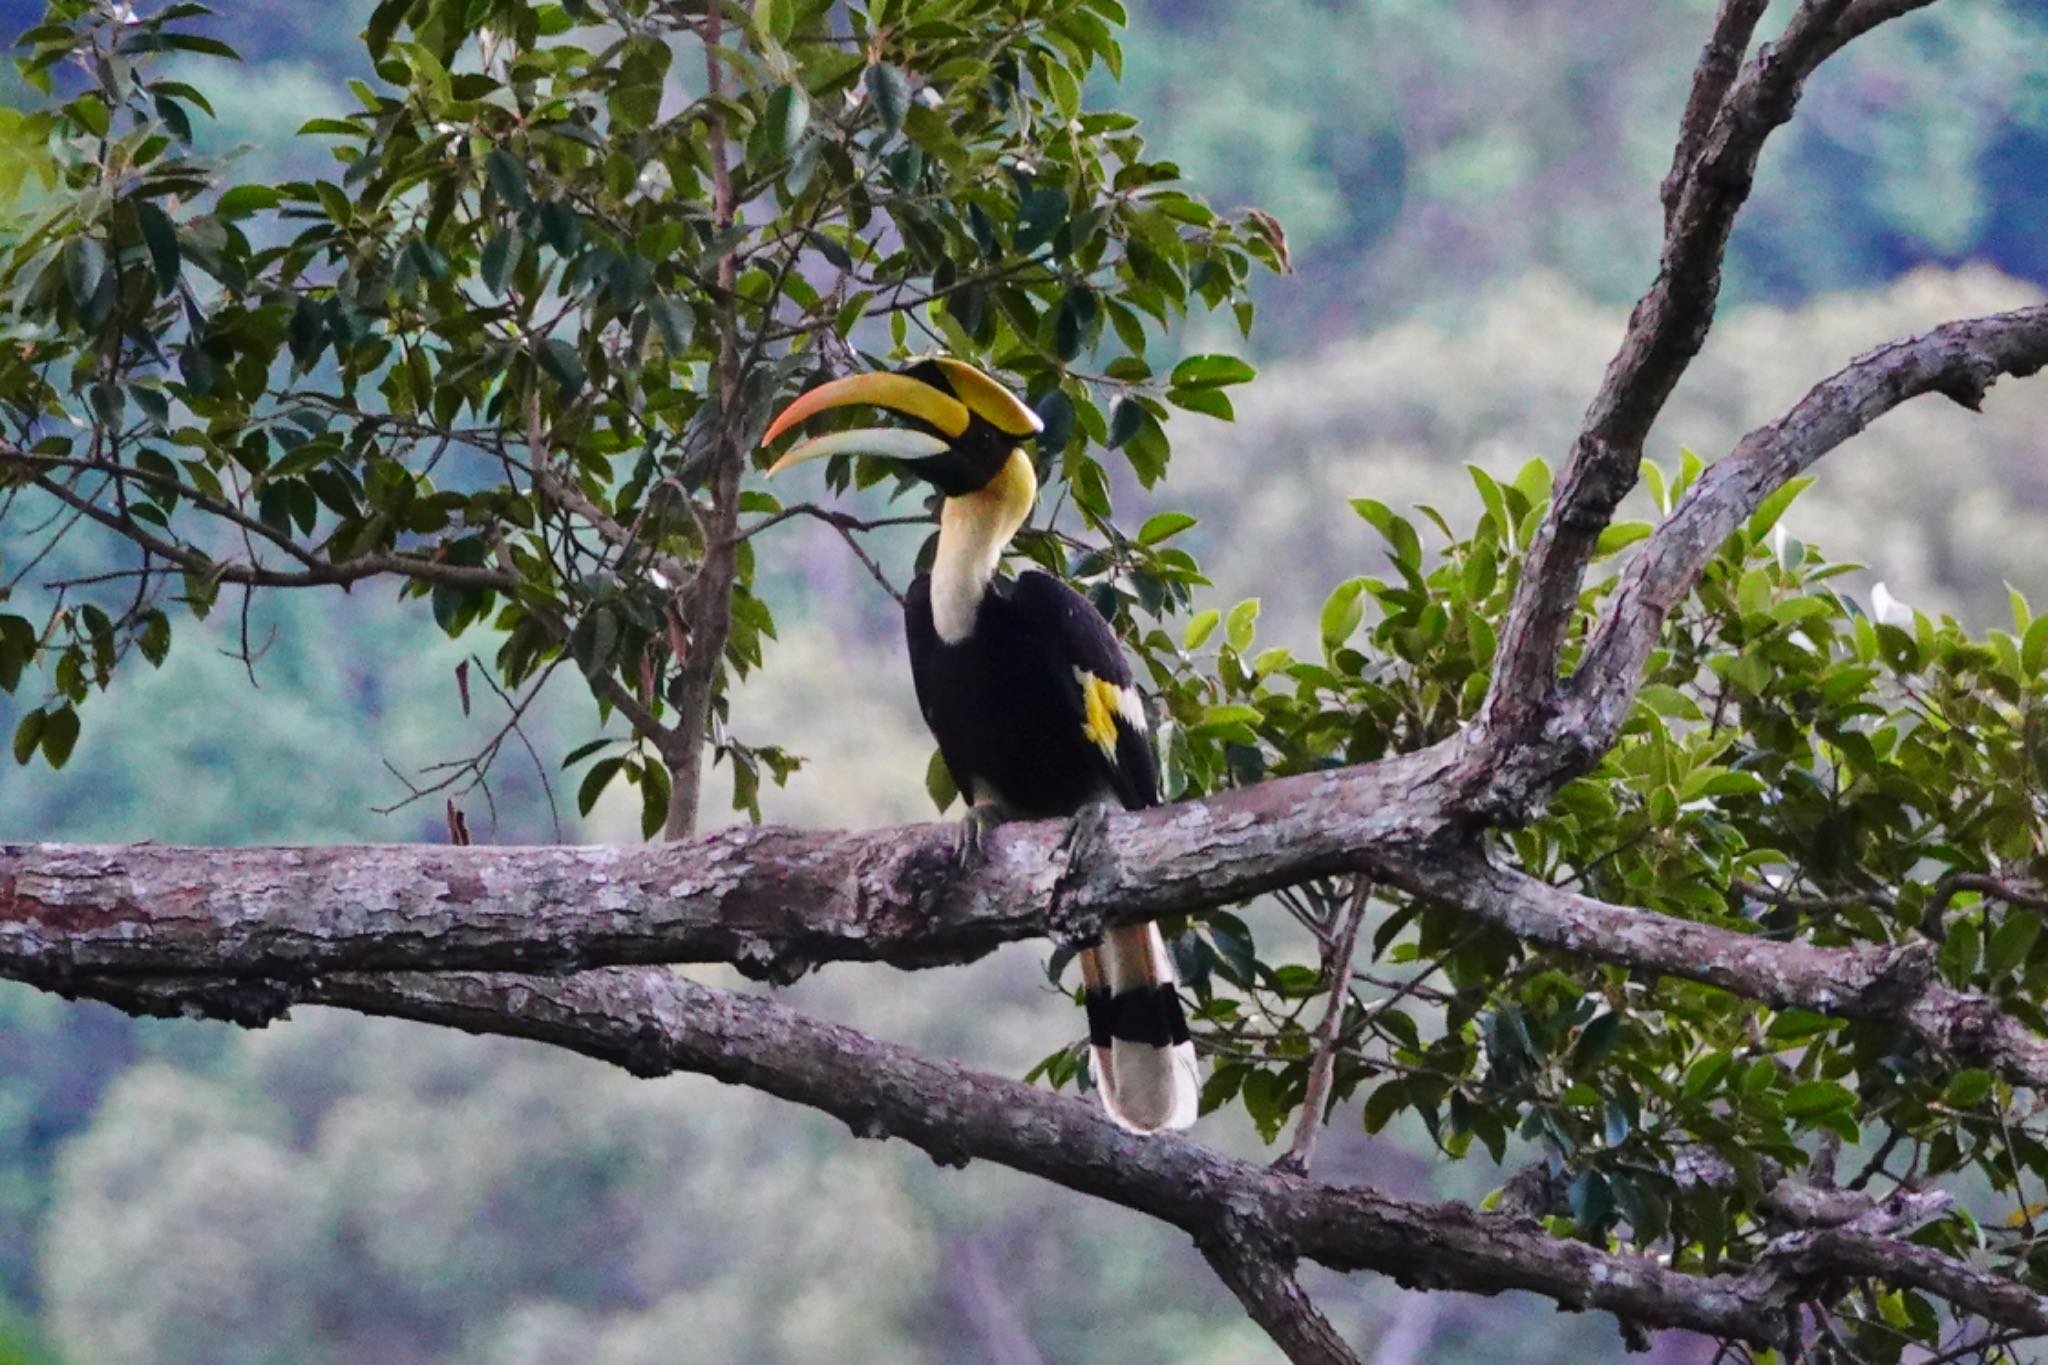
[762, 358, 1200, 1132]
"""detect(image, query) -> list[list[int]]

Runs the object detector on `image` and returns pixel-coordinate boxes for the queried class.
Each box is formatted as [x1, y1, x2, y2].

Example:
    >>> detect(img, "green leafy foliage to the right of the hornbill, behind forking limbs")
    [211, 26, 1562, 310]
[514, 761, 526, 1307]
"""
[1042, 452, 2048, 1361]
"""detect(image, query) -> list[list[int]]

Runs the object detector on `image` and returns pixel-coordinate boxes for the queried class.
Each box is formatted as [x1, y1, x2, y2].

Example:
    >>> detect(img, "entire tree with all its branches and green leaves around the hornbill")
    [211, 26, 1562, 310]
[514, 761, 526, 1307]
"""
[0, 0, 2048, 1361]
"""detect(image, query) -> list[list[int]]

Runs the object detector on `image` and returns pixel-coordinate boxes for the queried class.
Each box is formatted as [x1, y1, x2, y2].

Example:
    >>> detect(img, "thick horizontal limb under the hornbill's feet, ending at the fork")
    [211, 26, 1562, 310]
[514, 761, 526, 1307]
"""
[0, 755, 1448, 984]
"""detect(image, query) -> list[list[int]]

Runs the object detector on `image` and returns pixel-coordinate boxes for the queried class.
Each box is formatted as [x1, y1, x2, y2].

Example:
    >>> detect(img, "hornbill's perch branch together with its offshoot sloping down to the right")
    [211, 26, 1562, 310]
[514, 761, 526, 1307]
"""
[16, 806, 2048, 1089]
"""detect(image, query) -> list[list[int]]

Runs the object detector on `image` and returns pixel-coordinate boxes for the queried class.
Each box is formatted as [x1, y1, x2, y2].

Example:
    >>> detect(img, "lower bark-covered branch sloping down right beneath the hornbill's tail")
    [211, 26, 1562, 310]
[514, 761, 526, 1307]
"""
[59, 970, 2048, 1361]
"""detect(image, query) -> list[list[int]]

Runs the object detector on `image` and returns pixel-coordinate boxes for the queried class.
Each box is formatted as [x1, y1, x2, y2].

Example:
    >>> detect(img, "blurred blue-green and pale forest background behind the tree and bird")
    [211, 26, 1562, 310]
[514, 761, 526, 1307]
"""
[0, 0, 2048, 1365]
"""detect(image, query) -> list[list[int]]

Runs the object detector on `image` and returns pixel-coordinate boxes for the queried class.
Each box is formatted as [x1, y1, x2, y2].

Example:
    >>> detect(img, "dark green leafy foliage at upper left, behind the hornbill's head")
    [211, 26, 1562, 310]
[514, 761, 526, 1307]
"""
[0, 0, 1278, 831]
